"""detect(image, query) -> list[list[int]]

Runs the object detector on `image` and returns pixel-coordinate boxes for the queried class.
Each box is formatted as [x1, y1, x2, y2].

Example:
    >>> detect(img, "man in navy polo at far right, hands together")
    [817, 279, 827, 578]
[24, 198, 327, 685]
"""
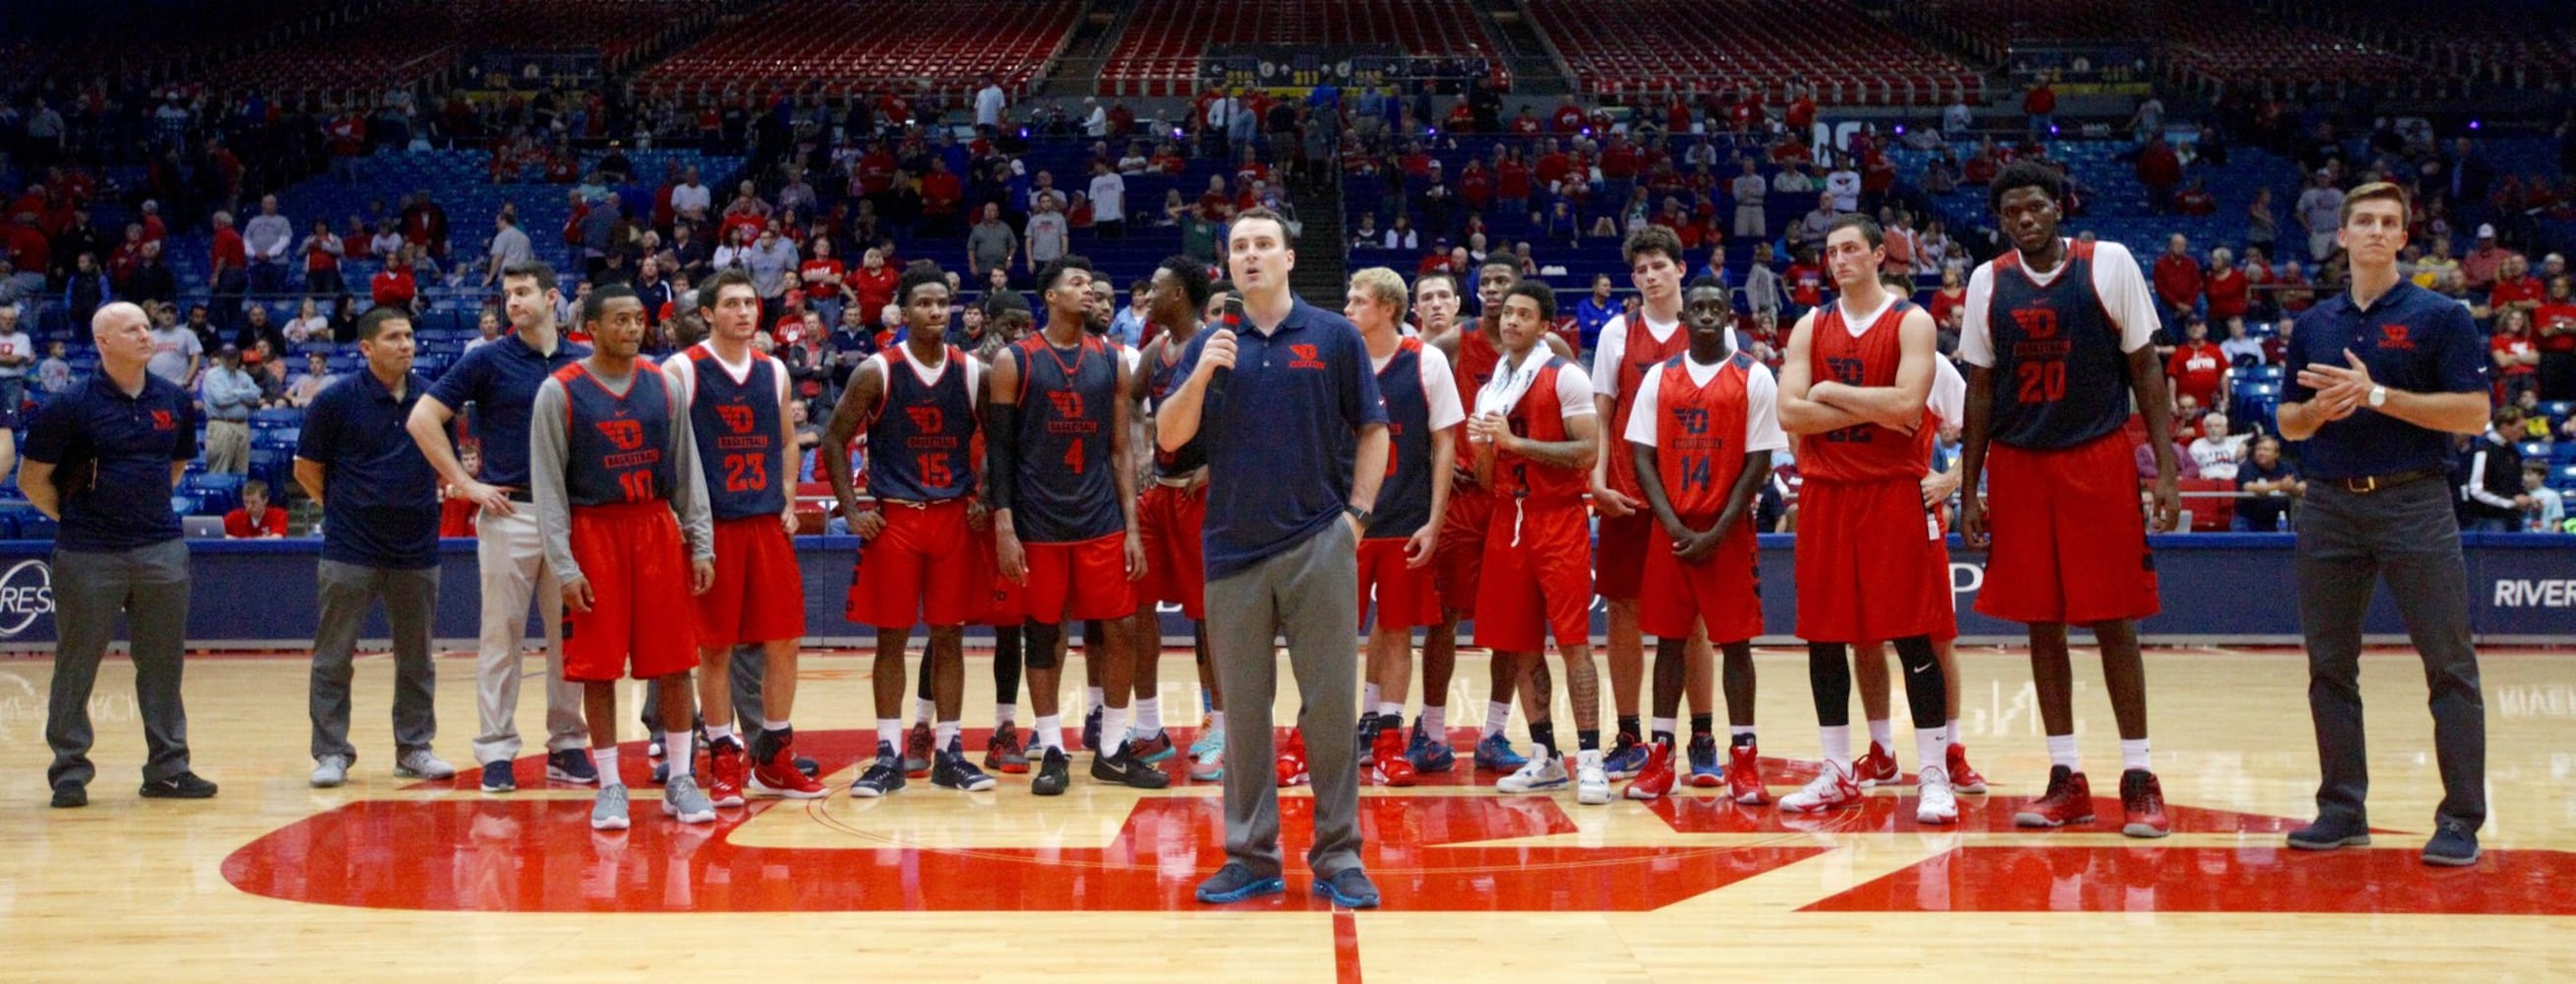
[2280, 183, 2488, 866]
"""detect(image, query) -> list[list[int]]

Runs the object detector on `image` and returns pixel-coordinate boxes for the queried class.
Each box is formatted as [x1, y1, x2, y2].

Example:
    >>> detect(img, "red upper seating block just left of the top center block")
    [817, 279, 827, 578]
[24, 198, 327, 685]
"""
[641, 0, 1082, 92]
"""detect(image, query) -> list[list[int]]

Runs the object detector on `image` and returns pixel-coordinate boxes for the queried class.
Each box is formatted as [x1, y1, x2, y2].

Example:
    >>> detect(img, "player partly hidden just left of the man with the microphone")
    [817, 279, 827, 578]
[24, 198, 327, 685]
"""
[1122, 255, 1227, 780]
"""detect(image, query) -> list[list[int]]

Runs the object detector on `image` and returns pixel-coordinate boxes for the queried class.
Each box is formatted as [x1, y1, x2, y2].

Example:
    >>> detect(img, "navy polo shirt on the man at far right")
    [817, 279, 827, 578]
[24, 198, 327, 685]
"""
[2280, 280, 2486, 482]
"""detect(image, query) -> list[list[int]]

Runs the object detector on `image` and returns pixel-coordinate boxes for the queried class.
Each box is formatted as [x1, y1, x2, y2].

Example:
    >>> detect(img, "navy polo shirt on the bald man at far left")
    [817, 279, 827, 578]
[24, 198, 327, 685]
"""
[26, 371, 196, 554]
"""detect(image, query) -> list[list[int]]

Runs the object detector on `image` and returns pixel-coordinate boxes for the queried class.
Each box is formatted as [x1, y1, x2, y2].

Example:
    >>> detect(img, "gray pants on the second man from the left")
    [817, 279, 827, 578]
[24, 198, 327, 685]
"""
[307, 559, 438, 763]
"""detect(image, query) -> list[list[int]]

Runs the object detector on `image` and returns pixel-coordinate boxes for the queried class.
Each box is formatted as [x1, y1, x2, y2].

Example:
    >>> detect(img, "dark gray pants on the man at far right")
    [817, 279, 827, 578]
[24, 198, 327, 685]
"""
[2298, 479, 2486, 832]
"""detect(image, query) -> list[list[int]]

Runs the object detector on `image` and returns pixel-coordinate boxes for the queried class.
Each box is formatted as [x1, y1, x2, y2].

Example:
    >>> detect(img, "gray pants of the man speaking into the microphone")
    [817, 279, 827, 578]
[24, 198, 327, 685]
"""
[1208, 521, 1360, 879]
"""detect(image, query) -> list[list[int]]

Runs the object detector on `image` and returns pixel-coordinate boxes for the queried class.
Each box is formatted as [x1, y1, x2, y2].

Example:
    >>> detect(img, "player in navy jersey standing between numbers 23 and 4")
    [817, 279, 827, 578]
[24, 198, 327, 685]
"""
[824, 266, 994, 799]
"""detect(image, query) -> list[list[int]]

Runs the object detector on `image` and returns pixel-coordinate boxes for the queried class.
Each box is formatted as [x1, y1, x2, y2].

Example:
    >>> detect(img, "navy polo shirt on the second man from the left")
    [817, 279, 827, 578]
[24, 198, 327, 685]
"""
[296, 368, 443, 570]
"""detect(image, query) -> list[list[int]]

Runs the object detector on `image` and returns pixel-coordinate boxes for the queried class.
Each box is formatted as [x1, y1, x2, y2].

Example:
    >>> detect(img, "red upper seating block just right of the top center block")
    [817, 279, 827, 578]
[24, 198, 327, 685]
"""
[1528, 0, 1986, 105]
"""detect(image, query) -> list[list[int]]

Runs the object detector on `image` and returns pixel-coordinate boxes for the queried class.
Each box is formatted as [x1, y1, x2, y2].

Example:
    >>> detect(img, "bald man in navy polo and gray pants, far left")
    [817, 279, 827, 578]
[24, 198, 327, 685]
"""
[18, 301, 213, 806]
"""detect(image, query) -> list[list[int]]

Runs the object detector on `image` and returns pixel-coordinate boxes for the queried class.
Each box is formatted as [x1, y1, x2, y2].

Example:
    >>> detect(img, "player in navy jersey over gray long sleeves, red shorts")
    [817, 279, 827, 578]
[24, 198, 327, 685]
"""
[528, 283, 716, 830]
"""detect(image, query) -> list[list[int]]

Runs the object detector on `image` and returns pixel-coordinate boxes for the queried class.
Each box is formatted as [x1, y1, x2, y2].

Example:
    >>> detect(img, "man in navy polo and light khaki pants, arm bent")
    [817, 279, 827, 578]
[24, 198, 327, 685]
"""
[407, 260, 600, 793]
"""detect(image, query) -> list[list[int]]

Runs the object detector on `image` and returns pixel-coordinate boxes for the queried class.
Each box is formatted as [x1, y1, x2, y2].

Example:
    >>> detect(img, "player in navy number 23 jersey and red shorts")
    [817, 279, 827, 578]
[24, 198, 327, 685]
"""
[662, 271, 824, 806]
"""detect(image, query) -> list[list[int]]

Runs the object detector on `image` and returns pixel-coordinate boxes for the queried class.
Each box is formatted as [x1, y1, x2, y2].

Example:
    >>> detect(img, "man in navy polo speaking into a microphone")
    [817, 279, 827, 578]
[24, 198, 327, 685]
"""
[1154, 209, 1389, 906]
